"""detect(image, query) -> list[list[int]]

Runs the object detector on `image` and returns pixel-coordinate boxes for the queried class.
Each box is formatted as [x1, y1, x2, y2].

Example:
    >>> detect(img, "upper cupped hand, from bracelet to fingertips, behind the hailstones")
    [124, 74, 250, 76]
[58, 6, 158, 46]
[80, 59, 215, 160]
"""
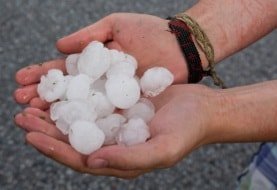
[14, 13, 187, 110]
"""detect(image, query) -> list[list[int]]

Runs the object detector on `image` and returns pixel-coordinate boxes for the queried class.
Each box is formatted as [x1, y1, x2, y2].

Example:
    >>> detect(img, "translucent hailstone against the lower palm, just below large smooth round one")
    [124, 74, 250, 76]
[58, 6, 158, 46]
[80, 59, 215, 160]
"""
[123, 98, 155, 123]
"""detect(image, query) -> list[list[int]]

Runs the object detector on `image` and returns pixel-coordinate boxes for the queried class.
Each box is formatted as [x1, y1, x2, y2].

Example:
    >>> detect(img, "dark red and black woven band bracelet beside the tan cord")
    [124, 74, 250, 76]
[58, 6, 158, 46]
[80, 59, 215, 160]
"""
[168, 18, 207, 83]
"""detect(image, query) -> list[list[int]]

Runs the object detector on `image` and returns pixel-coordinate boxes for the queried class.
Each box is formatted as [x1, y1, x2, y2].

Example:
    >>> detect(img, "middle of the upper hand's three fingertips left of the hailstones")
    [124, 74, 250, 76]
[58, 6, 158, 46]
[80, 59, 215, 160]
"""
[14, 84, 38, 104]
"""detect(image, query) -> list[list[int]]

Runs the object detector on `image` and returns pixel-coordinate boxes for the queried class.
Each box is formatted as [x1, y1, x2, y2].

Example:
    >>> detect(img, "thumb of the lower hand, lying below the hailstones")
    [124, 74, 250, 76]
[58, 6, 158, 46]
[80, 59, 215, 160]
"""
[88, 137, 172, 170]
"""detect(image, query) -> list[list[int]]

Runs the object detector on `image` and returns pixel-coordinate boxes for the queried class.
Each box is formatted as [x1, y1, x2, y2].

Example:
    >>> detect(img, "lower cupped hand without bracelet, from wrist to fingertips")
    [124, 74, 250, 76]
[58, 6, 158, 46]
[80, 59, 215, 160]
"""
[15, 85, 216, 178]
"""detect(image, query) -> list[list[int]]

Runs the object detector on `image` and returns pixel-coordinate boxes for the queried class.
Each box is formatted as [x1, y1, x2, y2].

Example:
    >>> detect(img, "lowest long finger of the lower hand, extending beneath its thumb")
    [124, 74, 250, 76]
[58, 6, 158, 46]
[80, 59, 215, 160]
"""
[26, 132, 149, 178]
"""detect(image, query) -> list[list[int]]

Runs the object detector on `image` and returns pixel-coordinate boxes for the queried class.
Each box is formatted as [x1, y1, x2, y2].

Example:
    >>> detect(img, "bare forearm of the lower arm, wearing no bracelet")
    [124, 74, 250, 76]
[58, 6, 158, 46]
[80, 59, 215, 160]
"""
[209, 81, 277, 142]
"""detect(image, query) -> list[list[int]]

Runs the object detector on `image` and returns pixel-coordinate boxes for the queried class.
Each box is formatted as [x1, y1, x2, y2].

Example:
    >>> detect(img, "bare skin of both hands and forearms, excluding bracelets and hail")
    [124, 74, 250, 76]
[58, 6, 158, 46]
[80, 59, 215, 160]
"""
[14, 0, 277, 178]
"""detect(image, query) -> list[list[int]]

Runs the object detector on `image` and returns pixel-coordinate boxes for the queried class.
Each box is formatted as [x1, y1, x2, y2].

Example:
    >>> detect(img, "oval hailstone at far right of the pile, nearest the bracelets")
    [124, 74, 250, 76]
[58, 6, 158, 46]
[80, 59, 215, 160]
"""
[140, 67, 174, 97]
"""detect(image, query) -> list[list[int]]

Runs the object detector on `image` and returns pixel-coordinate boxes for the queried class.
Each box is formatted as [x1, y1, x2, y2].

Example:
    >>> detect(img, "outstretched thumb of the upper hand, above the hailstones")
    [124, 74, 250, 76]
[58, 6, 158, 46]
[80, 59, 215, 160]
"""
[56, 16, 112, 54]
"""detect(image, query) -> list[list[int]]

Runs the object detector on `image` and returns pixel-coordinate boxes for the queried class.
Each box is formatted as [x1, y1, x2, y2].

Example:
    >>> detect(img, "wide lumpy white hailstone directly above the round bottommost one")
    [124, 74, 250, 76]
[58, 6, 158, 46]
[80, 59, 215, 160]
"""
[50, 100, 97, 135]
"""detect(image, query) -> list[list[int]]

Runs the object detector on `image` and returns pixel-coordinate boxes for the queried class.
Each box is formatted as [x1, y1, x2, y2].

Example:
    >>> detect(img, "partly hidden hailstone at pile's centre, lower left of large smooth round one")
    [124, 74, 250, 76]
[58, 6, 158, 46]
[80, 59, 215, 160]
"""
[88, 91, 115, 118]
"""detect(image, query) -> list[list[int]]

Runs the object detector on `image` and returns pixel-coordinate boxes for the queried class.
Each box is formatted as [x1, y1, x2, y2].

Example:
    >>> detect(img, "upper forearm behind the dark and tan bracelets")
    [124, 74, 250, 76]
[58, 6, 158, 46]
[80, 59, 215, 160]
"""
[183, 0, 277, 67]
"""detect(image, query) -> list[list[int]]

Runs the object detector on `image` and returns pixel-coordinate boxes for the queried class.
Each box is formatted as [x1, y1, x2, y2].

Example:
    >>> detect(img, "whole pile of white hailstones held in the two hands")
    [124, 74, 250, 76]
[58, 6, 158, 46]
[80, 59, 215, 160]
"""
[37, 41, 173, 155]
